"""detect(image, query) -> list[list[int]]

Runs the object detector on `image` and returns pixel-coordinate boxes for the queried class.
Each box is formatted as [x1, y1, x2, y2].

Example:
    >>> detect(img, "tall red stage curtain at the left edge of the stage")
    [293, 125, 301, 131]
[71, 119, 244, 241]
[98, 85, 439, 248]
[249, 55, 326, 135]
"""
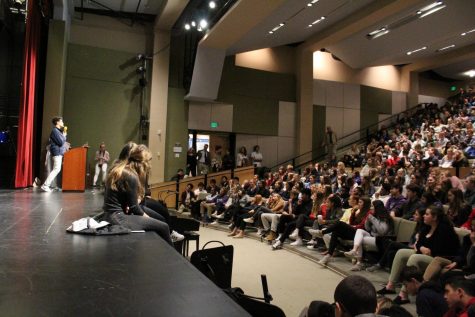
[15, 0, 42, 188]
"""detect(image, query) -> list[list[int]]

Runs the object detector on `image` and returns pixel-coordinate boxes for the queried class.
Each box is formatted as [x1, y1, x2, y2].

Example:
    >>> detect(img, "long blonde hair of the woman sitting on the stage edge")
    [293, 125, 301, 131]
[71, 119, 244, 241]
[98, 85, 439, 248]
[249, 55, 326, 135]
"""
[106, 143, 152, 198]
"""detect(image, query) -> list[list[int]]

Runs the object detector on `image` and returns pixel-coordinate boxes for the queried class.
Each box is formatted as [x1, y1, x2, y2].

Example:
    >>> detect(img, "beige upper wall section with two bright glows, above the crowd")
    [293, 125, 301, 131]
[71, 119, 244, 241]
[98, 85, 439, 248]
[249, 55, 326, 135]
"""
[313, 51, 405, 91]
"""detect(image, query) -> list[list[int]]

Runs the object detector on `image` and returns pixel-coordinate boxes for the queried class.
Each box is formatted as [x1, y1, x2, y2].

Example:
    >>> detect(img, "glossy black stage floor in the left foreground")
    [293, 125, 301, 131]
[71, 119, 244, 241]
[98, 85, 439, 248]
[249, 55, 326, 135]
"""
[0, 189, 253, 316]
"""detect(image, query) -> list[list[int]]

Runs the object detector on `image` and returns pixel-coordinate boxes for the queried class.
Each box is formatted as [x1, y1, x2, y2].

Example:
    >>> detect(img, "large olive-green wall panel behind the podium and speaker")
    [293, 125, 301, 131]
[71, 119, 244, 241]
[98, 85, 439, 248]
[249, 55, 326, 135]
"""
[63, 44, 148, 173]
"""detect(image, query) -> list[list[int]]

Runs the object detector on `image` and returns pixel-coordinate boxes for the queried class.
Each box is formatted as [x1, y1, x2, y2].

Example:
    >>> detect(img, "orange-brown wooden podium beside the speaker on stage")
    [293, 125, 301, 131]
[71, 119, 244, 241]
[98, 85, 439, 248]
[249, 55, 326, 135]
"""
[62, 147, 87, 191]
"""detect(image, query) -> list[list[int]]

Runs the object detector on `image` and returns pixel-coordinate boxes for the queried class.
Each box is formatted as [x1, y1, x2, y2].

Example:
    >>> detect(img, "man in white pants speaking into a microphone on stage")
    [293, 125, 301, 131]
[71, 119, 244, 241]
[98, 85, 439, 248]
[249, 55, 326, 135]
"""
[41, 117, 67, 192]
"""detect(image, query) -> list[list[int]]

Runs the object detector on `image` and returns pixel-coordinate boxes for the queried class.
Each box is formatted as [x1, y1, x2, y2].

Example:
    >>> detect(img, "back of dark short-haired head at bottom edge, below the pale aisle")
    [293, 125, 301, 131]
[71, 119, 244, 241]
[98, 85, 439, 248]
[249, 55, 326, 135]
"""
[333, 275, 377, 317]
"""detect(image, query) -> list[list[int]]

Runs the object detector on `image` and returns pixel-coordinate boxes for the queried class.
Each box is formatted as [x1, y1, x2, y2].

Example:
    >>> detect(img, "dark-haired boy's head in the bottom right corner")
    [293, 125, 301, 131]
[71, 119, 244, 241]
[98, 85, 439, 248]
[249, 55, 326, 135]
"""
[444, 277, 475, 317]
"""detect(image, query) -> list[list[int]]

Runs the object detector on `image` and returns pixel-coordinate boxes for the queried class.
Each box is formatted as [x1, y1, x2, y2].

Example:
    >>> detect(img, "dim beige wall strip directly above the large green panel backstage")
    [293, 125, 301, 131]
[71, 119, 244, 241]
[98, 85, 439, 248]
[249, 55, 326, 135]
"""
[70, 14, 153, 54]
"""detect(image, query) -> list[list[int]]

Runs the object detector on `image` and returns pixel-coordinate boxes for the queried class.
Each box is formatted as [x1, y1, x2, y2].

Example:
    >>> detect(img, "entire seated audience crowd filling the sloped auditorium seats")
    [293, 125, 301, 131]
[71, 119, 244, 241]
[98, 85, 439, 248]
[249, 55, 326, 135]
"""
[181, 93, 475, 316]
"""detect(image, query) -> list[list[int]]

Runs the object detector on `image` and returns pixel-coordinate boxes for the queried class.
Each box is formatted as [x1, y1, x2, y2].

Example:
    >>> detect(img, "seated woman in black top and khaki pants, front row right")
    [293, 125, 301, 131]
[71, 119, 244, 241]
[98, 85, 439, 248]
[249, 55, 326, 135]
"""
[378, 206, 460, 304]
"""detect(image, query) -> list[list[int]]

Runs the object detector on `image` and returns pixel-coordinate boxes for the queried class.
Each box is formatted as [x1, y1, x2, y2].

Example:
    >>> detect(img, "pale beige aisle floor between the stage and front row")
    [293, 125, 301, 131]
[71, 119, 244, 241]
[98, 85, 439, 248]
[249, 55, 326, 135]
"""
[195, 227, 342, 317]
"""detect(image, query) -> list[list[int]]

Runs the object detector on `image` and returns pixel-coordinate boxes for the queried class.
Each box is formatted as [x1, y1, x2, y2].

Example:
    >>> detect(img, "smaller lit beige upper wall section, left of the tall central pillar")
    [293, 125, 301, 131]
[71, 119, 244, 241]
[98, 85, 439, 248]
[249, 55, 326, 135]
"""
[236, 46, 295, 74]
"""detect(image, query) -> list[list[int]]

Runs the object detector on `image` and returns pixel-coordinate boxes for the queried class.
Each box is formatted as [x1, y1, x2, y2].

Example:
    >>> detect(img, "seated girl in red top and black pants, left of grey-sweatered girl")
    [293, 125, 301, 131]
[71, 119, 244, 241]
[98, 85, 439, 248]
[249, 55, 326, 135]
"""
[317, 196, 371, 265]
